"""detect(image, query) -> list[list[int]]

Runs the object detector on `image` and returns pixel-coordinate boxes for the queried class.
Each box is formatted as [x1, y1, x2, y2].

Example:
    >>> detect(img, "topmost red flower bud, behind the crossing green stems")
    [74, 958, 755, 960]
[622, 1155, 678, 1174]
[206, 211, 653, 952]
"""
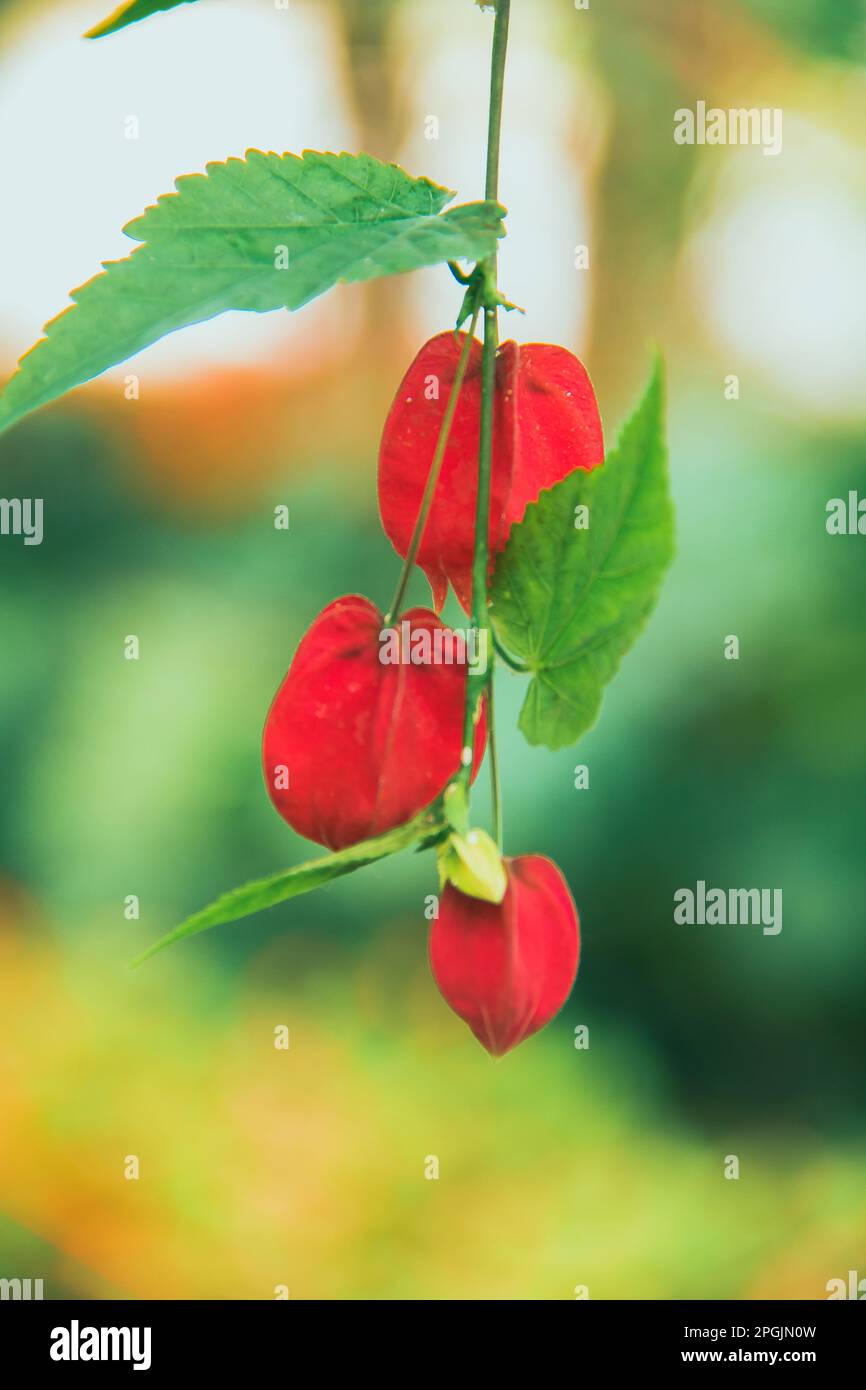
[378, 332, 605, 613]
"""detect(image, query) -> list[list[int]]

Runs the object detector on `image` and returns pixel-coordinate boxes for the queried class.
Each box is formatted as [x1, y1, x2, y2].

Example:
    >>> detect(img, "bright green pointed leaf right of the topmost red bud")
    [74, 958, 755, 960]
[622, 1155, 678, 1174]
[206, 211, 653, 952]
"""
[491, 360, 674, 748]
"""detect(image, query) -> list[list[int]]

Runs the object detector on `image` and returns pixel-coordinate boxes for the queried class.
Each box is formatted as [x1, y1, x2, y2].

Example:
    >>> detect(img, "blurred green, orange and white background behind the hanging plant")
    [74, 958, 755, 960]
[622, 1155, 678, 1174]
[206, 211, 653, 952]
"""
[0, 0, 866, 1300]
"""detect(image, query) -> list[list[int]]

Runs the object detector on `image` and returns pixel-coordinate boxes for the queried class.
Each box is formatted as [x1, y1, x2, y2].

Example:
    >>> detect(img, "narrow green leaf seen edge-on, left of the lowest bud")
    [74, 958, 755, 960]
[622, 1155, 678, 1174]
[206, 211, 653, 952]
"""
[131, 810, 443, 967]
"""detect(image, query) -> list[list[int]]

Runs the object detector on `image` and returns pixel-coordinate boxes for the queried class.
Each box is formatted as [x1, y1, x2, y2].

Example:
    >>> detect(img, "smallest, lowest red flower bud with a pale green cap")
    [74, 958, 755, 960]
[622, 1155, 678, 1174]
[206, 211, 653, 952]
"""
[430, 855, 580, 1056]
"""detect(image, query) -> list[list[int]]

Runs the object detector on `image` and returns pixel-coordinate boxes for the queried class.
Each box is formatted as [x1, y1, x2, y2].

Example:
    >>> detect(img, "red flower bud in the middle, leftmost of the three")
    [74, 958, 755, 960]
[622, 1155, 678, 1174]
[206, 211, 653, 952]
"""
[263, 595, 487, 849]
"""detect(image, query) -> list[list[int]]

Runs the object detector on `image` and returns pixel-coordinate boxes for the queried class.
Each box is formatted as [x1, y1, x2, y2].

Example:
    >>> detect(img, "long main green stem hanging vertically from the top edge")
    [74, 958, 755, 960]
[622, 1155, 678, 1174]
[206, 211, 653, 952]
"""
[461, 0, 512, 785]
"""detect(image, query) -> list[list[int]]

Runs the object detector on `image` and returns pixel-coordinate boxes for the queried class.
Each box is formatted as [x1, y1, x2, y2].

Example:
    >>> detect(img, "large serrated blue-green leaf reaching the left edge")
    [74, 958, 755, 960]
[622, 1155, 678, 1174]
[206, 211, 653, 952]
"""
[0, 150, 505, 430]
